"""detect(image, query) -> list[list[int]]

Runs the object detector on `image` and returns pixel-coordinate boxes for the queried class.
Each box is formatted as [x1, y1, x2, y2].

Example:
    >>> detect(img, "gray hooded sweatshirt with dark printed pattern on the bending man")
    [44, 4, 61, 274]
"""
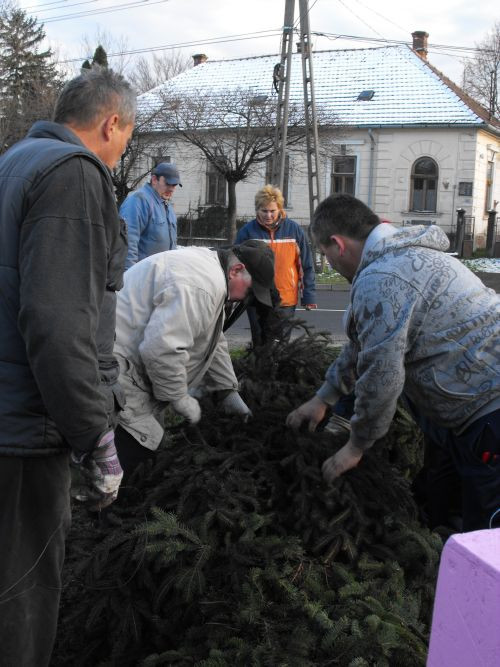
[318, 224, 500, 449]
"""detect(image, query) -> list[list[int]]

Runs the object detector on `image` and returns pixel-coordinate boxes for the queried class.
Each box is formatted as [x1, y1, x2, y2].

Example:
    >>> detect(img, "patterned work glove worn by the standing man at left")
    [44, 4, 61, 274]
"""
[71, 431, 123, 512]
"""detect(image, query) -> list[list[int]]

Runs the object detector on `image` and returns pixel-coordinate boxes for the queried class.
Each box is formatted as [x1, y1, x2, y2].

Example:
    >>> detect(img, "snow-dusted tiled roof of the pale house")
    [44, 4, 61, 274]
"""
[139, 45, 499, 127]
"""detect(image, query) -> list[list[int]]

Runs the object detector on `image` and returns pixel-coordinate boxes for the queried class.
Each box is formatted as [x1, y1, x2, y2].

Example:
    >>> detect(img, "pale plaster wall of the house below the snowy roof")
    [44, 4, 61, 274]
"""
[143, 128, 500, 247]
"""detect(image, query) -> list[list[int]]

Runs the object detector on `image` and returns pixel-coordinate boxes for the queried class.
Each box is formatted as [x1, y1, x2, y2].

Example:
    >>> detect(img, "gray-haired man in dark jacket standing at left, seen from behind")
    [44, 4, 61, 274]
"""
[0, 66, 135, 667]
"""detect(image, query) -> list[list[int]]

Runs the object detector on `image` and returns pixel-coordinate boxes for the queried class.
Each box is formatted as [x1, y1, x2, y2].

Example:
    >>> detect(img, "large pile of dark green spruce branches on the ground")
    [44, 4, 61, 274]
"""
[52, 333, 441, 667]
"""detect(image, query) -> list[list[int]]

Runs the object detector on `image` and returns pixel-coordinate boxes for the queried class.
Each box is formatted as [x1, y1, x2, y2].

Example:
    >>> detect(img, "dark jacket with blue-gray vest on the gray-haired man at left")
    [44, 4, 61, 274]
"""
[0, 121, 126, 456]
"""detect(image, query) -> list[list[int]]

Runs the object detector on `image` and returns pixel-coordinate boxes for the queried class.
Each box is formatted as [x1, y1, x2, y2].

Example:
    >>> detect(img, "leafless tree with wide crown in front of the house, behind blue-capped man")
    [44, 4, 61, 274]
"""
[152, 88, 335, 242]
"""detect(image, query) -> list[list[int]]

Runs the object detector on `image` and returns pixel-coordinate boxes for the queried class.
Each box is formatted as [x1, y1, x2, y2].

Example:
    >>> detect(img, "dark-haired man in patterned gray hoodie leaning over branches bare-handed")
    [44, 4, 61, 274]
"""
[287, 195, 500, 530]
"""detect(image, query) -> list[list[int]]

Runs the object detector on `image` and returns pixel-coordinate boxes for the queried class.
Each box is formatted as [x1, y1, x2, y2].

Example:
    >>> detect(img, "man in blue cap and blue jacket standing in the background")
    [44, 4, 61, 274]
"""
[120, 162, 182, 269]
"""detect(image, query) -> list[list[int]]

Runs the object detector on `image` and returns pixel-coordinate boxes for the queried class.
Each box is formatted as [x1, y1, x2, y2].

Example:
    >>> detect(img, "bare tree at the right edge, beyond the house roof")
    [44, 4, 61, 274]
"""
[462, 21, 500, 117]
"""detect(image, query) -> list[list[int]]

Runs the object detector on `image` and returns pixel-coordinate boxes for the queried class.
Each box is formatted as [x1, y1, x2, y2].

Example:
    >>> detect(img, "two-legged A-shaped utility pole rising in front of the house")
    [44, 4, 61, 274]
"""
[272, 0, 321, 237]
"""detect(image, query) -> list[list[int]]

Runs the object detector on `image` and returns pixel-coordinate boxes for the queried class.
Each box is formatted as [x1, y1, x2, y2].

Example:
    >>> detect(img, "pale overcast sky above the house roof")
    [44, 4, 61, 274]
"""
[20, 0, 500, 83]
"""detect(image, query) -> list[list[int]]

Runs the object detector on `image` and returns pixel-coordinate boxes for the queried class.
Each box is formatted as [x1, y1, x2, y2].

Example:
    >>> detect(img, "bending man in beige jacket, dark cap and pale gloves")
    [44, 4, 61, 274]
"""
[114, 241, 274, 476]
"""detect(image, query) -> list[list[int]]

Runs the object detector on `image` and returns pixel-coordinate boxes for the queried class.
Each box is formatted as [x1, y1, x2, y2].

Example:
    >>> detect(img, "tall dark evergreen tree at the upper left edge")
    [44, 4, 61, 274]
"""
[0, 7, 61, 152]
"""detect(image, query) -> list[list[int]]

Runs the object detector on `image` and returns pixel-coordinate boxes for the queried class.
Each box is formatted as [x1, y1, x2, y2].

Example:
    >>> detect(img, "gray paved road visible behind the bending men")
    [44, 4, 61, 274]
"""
[226, 287, 349, 347]
